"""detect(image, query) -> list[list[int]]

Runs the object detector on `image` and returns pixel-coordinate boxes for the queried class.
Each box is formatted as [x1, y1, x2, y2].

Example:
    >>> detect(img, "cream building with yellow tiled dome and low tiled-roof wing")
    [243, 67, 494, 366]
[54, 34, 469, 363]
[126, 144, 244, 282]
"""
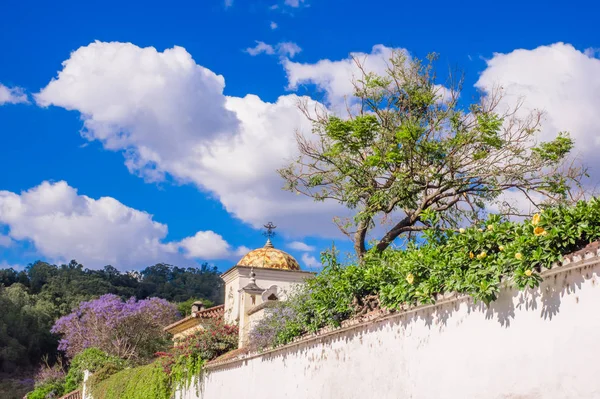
[165, 238, 314, 348]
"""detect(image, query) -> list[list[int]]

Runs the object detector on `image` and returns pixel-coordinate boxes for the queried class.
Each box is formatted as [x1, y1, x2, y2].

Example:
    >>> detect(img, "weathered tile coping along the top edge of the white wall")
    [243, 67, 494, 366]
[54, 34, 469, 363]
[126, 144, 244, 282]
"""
[204, 241, 600, 371]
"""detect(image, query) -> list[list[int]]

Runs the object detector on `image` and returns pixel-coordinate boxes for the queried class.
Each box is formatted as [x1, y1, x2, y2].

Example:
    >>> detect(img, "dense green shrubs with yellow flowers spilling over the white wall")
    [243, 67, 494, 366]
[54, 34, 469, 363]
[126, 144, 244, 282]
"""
[257, 199, 600, 346]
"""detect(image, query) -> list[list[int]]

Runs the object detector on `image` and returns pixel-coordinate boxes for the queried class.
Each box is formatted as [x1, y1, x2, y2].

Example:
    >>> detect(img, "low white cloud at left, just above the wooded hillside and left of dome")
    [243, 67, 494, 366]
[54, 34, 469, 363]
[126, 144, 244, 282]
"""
[0, 181, 246, 269]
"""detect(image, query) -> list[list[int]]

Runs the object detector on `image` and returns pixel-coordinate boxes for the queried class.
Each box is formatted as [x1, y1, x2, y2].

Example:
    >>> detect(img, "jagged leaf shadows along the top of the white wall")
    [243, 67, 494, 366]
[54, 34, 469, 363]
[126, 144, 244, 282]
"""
[199, 259, 599, 382]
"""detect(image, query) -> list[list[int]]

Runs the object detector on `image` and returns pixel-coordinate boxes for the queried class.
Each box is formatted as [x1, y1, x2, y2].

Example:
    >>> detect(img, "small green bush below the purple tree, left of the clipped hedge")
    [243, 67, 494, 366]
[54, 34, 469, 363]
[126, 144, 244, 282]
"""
[65, 348, 128, 392]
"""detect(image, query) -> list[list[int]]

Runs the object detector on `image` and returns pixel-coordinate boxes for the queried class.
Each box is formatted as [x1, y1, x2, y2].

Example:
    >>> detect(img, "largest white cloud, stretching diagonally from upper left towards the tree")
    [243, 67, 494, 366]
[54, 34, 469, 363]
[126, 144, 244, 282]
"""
[36, 42, 341, 236]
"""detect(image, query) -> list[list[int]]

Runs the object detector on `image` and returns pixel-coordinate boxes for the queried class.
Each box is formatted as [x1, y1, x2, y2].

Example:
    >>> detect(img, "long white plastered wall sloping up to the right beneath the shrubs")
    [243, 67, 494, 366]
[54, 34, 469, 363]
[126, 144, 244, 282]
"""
[181, 258, 600, 399]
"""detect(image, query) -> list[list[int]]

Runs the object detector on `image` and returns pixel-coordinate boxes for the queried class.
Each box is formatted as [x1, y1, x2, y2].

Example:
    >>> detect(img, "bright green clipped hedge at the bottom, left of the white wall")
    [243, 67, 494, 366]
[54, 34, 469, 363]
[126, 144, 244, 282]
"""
[90, 361, 171, 399]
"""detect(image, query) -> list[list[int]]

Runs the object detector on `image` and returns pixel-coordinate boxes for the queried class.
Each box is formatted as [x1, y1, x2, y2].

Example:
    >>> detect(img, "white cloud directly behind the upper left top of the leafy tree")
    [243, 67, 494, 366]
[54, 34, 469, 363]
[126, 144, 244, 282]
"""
[283, 44, 405, 112]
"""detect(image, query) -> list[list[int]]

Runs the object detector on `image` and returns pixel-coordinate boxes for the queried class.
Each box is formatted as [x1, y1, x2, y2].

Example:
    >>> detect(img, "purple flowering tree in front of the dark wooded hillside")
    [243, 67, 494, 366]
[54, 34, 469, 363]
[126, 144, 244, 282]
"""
[52, 294, 179, 360]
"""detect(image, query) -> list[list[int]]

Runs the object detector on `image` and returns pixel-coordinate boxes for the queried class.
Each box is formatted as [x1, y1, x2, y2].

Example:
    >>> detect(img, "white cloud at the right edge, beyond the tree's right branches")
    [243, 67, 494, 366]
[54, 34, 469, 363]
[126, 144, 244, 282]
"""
[476, 43, 600, 188]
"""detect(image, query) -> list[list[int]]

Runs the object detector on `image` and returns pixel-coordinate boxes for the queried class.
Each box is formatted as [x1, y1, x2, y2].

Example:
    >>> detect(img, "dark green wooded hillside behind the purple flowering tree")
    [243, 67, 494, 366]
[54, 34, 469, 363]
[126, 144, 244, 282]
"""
[0, 261, 223, 372]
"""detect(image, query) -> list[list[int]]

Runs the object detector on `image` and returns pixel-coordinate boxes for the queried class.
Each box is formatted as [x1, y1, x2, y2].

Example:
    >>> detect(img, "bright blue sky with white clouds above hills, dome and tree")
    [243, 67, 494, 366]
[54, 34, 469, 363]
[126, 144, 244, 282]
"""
[0, 0, 600, 270]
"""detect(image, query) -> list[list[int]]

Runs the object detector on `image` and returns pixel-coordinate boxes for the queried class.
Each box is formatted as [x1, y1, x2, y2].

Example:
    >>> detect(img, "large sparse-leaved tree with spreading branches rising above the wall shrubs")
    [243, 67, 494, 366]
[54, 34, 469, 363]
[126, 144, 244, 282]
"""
[278, 52, 584, 258]
